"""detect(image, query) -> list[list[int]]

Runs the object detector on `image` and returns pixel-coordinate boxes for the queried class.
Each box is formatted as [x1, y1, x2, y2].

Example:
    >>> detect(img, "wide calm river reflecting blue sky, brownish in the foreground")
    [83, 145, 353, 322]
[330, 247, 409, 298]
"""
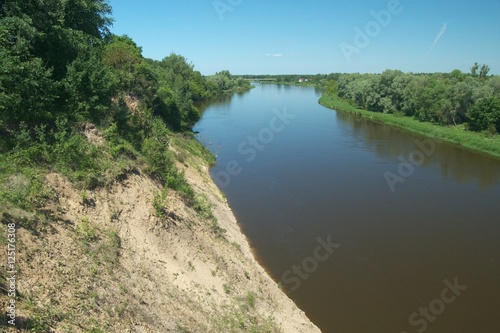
[194, 84, 500, 333]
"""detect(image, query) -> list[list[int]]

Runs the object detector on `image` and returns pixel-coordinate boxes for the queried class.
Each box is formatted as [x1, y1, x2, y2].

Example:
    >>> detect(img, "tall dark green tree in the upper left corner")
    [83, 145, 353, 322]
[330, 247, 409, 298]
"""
[0, 0, 111, 130]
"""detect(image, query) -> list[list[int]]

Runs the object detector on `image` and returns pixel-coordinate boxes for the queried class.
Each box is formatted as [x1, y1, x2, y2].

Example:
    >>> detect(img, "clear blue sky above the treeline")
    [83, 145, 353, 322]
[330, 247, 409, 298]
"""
[110, 0, 500, 75]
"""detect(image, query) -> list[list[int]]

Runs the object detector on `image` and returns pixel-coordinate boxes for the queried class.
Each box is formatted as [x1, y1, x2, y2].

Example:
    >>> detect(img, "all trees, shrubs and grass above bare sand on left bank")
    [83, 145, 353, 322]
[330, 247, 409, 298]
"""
[0, 0, 250, 208]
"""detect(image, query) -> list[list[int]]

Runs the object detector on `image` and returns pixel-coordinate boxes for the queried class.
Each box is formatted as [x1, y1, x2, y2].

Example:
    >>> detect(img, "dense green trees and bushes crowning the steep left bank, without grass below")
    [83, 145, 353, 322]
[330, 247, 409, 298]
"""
[0, 0, 250, 164]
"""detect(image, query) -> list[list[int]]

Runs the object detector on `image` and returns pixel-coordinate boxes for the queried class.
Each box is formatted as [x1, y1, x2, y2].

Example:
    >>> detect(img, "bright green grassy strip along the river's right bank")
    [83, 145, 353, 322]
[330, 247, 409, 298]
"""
[319, 93, 500, 158]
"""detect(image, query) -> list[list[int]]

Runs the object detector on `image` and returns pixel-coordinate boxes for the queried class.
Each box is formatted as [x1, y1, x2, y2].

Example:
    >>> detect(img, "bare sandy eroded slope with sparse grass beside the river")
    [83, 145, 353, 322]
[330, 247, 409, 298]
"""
[0, 127, 320, 333]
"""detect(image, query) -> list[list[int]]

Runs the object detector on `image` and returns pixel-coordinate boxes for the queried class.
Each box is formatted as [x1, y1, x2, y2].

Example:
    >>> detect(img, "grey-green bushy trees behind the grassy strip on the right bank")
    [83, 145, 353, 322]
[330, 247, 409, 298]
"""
[332, 64, 500, 133]
